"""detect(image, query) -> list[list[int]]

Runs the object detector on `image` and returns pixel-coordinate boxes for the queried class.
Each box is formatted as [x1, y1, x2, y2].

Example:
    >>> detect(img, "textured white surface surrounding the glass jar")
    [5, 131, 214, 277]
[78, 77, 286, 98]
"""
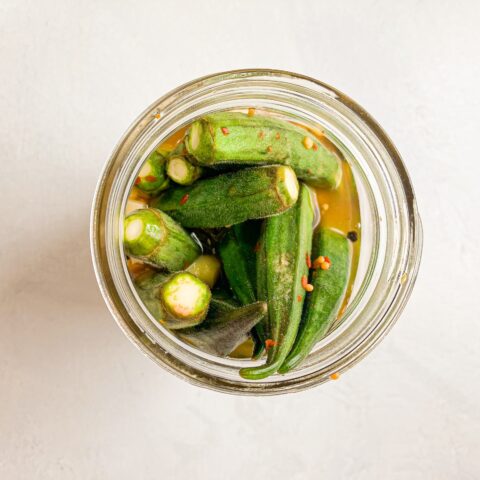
[0, 0, 480, 480]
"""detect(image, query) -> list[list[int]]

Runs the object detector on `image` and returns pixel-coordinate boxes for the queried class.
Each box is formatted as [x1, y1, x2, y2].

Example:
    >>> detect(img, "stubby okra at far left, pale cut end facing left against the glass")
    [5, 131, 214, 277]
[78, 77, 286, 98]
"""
[123, 208, 201, 271]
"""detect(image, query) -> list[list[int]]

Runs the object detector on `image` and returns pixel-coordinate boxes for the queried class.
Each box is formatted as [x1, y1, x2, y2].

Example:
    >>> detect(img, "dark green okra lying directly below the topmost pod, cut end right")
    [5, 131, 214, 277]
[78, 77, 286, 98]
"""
[151, 165, 299, 228]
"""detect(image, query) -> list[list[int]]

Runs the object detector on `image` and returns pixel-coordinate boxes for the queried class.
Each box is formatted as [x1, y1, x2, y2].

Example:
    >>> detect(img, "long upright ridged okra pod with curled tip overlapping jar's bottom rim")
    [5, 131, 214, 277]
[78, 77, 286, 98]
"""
[240, 185, 313, 380]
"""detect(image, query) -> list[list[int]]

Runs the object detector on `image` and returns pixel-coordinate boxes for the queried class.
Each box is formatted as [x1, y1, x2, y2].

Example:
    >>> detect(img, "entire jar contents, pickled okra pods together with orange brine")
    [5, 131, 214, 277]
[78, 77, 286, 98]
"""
[123, 108, 361, 381]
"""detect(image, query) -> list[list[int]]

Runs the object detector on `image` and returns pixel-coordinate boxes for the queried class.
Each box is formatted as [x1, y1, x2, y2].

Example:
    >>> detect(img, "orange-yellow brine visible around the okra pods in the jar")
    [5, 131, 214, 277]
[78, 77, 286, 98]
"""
[125, 115, 361, 358]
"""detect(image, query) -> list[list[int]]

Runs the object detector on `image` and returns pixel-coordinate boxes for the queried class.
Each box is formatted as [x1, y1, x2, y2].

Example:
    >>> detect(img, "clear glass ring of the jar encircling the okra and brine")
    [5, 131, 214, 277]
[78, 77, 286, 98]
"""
[91, 70, 422, 395]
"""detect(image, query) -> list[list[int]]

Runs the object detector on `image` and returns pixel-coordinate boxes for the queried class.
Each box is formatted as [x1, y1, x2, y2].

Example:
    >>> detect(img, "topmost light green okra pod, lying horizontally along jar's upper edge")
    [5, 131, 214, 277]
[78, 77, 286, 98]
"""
[185, 112, 342, 188]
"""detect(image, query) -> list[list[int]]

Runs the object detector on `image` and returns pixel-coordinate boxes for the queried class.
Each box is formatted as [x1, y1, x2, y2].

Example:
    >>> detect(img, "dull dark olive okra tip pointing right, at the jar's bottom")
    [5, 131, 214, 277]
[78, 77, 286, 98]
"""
[178, 302, 267, 357]
